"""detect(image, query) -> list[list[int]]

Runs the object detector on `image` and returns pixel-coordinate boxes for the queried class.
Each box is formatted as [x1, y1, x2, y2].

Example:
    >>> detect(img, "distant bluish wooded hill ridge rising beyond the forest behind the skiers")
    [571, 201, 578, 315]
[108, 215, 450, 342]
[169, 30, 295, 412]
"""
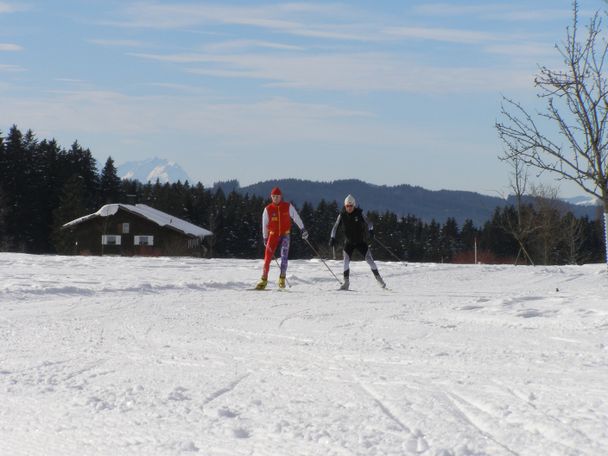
[215, 179, 597, 226]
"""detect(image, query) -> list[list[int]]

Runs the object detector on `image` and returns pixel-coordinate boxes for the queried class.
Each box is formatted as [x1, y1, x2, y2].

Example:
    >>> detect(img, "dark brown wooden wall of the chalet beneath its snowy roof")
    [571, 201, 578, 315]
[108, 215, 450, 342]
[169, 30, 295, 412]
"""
[68, 209, 202, 256]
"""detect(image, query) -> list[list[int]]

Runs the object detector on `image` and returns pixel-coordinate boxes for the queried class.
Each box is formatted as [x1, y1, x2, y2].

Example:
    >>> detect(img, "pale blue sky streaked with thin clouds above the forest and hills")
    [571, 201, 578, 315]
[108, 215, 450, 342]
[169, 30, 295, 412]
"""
[0, 0, 607, 196]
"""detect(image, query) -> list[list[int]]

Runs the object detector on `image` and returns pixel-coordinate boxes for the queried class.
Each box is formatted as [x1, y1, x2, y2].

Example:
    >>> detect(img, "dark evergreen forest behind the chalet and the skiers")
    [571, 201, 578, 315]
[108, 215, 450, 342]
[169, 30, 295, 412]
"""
[0, 126, 603, 264]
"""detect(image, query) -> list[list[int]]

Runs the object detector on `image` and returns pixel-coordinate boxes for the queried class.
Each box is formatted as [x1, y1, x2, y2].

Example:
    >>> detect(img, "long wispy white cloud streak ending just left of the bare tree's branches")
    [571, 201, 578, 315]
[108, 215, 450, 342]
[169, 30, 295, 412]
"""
[131, 53, 530, 93]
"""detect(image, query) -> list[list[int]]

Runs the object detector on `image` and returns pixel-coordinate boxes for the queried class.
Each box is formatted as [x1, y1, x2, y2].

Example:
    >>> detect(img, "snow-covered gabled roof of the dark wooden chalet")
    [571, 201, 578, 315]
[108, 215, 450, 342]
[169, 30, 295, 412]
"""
[63, 204, 213, 237]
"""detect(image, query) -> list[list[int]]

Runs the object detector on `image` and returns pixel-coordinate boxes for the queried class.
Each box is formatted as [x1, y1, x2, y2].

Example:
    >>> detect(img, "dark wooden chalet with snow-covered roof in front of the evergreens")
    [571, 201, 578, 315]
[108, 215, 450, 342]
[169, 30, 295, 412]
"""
[62, 204, 213, 256]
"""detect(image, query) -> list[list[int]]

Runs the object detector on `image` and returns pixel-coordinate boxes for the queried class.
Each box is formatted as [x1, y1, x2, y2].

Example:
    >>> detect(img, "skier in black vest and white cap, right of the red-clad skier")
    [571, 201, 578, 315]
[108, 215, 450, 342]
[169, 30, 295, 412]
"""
[329, 195, 386, 290]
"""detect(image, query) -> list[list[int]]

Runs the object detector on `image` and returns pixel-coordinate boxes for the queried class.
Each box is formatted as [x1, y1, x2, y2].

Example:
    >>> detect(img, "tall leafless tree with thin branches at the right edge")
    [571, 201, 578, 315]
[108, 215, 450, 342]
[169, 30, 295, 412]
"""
[496, 1, 608, 264]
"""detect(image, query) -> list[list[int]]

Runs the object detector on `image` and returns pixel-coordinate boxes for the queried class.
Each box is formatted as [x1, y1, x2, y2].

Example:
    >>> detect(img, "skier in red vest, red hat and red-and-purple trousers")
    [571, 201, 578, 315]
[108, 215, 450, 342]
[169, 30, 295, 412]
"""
[255, 187, 308, 290]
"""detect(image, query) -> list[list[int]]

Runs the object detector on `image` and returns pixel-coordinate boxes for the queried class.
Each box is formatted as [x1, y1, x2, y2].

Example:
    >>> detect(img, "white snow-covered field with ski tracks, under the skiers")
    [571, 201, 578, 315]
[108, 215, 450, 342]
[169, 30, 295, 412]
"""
[0, 253, 608, 456]
